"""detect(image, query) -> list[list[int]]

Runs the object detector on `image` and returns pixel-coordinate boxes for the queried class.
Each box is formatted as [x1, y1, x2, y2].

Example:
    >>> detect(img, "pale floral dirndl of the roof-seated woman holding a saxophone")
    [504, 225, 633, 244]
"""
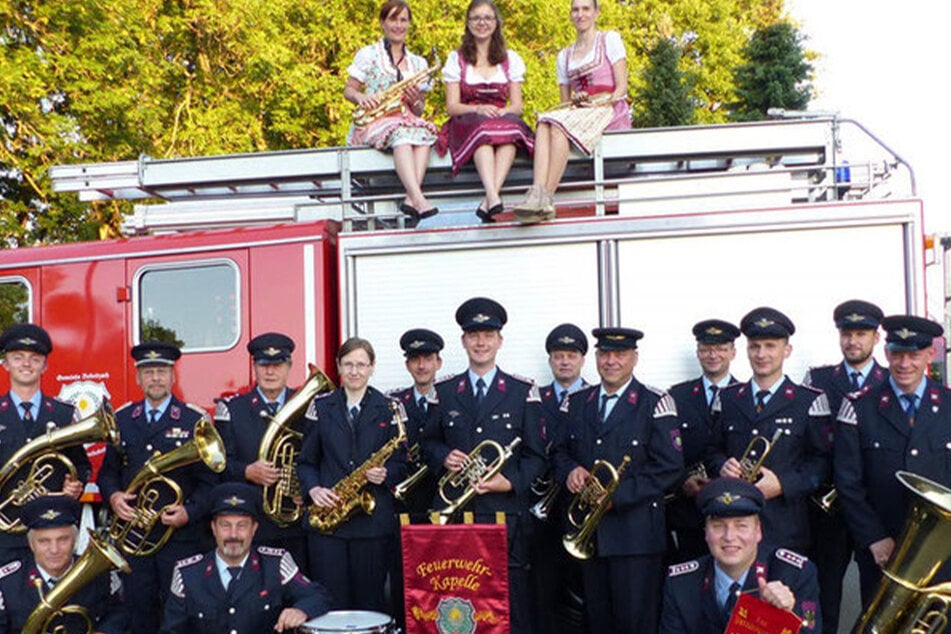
[347, 39, 437, 150]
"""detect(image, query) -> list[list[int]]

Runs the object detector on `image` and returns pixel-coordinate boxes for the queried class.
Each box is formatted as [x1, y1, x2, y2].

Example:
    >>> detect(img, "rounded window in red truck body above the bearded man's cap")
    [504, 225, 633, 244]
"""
[138, 263, 241, 352]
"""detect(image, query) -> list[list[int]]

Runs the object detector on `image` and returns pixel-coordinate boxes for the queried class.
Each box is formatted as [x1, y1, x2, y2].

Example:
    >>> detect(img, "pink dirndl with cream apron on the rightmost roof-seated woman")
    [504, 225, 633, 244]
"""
[538, 31, 631, 156]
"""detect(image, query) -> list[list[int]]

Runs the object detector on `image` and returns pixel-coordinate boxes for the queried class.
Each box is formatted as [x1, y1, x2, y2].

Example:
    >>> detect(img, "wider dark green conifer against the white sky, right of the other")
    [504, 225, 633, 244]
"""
[732, 22, 812, 121]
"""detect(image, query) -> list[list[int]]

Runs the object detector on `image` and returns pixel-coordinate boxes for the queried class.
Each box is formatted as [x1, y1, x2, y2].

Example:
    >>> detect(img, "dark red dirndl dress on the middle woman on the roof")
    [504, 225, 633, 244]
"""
[436, 51, 535, 174]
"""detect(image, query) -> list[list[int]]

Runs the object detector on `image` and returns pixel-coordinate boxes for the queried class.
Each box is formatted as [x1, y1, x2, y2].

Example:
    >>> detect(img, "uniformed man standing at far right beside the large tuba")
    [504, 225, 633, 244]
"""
[835, 315, 951, 605]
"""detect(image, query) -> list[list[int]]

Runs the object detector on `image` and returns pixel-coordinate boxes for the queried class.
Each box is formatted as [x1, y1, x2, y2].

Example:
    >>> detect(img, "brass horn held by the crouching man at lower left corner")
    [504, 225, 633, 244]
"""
[20, 529, 130, 634]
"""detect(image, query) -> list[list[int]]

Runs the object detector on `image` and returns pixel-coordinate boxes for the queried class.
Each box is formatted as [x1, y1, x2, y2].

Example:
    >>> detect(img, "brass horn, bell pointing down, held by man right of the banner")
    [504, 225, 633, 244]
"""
[561, 456, 631, 559]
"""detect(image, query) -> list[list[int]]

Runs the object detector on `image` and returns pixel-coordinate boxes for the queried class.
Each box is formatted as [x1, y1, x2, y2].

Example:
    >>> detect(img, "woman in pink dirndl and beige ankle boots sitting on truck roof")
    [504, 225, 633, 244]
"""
[514, 0, 631, 221]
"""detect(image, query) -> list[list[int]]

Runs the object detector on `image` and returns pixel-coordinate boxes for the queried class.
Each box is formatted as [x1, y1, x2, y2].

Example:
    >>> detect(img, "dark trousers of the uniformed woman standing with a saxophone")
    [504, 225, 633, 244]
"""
[307, 533, 393, 614]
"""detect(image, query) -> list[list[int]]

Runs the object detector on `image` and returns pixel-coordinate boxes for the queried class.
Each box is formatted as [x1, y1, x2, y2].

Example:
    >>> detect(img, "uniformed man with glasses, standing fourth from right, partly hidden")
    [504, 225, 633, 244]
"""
[667, 319, 740, 563]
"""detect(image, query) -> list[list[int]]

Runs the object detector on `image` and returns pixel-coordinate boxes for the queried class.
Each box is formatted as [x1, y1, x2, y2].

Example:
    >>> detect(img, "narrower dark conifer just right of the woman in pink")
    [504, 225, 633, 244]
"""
[634, 38, 694, 128]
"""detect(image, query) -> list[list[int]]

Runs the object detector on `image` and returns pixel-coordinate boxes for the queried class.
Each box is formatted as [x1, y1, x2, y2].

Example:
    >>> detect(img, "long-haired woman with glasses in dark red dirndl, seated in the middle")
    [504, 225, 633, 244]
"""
[436, 0, 533, 222]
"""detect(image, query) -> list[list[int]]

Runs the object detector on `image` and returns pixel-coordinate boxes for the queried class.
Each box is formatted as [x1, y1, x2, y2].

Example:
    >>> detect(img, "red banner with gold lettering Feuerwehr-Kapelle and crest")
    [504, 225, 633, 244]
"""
[402, 524, 509, 634]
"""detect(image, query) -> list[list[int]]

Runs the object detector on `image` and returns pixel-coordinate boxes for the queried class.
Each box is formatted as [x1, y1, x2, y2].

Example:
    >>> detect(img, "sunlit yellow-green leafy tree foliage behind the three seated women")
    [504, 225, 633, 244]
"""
[0, 0, 783, 245]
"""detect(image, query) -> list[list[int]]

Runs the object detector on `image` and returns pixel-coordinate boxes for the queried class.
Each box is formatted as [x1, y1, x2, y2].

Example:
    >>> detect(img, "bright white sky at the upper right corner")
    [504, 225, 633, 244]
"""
[786, 0, 951, 233]
